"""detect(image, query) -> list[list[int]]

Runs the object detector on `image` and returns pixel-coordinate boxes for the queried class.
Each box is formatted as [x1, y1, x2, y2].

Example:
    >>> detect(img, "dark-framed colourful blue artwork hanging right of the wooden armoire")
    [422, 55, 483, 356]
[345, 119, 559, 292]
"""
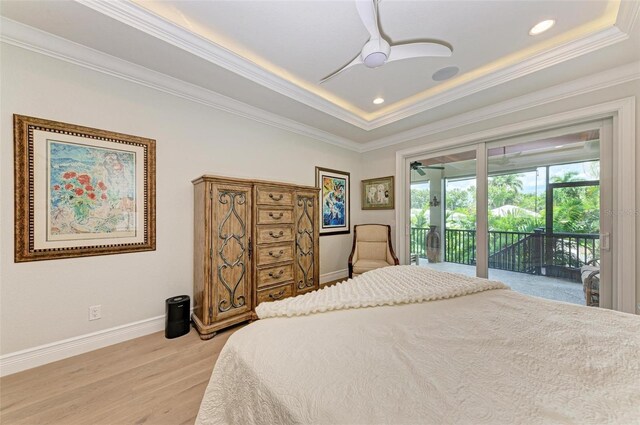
[316, 167, 351, 236]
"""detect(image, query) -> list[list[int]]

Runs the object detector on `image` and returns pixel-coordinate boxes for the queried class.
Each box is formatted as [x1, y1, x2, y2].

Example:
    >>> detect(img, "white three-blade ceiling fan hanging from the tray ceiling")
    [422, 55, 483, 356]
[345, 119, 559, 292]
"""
[320, 0, 452, 84]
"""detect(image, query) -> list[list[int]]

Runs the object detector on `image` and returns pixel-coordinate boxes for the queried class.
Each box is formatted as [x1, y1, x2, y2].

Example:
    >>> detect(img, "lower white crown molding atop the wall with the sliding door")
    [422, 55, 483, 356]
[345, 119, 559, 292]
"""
[360, 62, 640, 153]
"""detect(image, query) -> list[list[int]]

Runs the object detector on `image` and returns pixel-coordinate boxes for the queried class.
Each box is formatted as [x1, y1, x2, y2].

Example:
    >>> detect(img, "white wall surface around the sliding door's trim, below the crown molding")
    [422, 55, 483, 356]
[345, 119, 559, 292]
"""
[360, 80, 640, 312]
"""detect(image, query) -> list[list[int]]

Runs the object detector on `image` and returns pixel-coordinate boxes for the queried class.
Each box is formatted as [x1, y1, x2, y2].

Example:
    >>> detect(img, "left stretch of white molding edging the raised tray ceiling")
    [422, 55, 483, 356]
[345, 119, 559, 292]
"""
[75, 0, 368, 129]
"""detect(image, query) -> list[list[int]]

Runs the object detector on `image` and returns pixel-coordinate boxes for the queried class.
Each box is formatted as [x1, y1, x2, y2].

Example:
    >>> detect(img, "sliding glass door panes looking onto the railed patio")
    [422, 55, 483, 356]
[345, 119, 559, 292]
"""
[409, 121, 612, 308]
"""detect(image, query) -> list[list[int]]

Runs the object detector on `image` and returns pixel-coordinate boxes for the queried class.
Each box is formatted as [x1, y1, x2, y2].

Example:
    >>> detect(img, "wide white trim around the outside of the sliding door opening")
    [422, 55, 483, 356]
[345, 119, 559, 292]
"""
[395, 96, 637, 313]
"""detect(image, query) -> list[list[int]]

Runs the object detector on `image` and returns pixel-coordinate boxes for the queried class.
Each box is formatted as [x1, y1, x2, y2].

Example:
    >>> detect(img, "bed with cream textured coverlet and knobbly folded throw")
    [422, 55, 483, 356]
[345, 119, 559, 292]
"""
[196, 266, 640, 424]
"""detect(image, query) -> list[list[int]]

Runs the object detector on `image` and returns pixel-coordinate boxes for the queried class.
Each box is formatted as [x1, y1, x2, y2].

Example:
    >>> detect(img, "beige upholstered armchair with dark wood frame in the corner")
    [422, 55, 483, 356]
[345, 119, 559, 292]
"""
[349, 224, 400, 277]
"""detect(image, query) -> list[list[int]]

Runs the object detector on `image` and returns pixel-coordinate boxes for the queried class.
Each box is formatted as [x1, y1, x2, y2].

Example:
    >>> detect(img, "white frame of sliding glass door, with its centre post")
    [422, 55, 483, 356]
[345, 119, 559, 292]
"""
[395, 97, 640, 313]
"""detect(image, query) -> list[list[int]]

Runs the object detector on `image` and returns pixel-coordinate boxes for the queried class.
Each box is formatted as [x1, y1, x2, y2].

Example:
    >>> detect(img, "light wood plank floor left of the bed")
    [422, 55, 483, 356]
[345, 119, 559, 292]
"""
[0, 327, 239, 425]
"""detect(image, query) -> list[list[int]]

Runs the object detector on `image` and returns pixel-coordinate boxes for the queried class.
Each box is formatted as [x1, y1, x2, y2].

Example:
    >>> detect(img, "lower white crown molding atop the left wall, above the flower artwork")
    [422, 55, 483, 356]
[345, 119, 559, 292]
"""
[0, 17, 361, 152]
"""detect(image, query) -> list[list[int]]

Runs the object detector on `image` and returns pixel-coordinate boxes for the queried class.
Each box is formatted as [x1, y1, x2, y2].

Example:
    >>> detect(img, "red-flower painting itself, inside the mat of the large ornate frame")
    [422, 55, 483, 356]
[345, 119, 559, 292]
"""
[48, 140, 136, 238]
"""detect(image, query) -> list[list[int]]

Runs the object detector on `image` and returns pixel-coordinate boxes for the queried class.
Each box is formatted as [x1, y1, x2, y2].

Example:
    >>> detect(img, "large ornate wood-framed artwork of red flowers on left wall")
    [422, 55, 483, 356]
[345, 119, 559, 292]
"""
[13, 115, 156, 262]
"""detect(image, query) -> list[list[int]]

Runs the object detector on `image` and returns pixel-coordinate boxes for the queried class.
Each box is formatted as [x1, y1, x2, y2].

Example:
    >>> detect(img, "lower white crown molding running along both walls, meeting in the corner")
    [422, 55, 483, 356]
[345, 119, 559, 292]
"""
[0, 17, 640, 153]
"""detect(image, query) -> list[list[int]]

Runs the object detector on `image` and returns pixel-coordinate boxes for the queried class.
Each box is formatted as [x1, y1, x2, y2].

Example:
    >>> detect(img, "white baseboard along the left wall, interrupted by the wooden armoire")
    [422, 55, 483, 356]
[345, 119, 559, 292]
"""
[0, 269, 349, 376]
